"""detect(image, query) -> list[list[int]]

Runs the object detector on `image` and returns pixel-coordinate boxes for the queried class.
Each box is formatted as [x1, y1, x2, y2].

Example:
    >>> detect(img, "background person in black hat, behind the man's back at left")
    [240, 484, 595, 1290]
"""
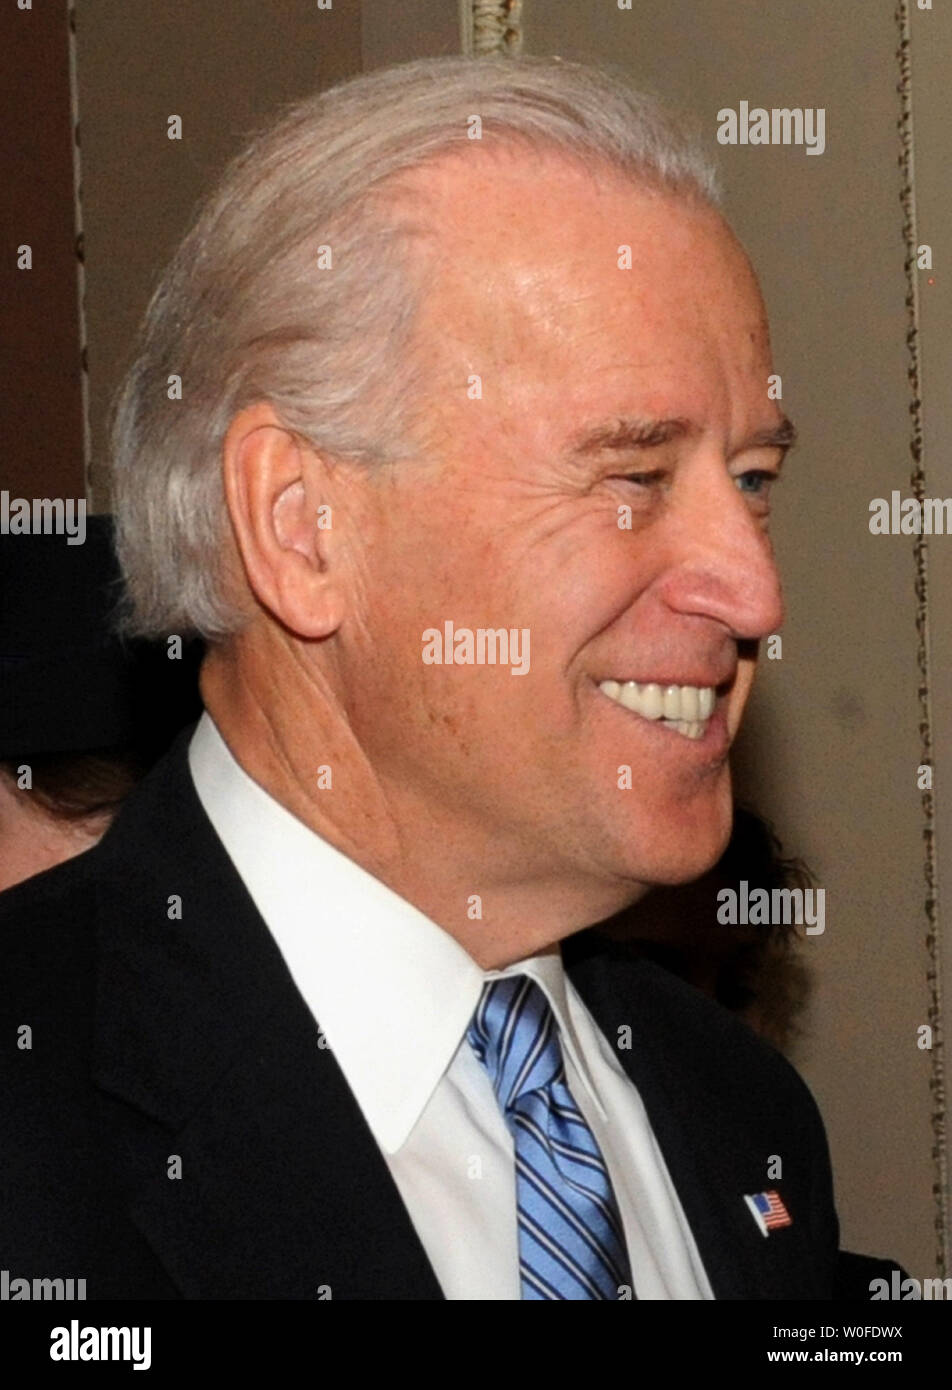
[0, 516, 200, 890]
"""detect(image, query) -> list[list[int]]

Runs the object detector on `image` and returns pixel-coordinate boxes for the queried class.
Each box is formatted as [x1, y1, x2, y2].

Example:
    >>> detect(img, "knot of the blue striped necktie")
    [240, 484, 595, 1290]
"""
[468, 974, 566, 1112]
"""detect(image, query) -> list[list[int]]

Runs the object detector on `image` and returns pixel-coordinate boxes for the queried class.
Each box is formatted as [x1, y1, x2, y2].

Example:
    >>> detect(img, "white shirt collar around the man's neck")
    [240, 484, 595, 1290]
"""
[189, 714, 602, 1154]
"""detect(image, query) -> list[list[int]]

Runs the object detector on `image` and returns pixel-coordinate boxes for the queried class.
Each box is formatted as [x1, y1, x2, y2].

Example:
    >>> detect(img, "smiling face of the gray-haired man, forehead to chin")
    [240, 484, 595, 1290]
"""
[339, 153, 782, 891]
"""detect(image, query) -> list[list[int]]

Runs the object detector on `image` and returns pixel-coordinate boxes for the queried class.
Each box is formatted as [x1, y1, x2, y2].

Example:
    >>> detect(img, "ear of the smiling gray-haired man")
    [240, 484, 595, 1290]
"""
[222, 402, 343, 638]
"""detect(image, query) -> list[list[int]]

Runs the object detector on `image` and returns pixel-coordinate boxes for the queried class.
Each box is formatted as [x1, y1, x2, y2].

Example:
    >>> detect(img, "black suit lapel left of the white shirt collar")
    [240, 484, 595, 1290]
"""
[96, 738, 442, 1300]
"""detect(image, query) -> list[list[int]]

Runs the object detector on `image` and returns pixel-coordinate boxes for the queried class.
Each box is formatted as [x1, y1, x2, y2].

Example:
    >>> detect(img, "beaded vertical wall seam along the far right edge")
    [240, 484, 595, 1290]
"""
[895, 0, 949, 1275]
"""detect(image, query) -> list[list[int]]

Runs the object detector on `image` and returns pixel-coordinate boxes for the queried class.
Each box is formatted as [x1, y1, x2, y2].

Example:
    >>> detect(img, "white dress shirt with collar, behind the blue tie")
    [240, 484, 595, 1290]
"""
[189, 714, 713, 1300]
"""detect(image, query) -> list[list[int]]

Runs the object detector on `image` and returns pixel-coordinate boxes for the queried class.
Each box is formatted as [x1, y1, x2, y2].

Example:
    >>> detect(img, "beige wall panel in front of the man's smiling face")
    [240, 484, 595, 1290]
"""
[524, 0, 952, 1277]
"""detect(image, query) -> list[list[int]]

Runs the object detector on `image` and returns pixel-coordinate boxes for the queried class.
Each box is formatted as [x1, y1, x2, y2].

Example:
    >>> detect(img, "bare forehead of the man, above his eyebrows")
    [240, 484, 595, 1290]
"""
[403, 142, 769, 419]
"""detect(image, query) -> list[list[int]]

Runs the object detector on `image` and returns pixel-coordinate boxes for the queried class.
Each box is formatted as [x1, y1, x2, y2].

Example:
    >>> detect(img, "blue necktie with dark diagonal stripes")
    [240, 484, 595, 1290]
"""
[467, 974, 631, 1300]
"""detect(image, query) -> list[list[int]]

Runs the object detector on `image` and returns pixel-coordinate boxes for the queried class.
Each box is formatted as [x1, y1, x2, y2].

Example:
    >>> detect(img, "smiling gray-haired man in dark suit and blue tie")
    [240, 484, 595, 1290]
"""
[0, 51, 837, 1300]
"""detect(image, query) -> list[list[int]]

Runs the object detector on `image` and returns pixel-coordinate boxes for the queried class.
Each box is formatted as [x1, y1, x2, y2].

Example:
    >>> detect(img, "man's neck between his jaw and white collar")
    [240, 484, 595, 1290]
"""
[202, 635, 644, 969]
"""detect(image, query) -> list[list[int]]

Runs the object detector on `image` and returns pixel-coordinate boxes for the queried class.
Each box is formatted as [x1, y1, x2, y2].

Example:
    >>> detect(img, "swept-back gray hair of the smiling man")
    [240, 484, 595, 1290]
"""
[110, 57, 719, 639]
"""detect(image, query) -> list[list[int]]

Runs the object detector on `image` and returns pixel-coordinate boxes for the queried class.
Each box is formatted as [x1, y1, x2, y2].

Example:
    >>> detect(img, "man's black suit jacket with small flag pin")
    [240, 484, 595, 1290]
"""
[0, 734, 837, 1300]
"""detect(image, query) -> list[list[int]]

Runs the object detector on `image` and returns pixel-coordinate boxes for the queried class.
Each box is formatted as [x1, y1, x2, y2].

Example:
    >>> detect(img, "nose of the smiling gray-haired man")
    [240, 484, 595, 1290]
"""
[662, 459, 784, 641]
